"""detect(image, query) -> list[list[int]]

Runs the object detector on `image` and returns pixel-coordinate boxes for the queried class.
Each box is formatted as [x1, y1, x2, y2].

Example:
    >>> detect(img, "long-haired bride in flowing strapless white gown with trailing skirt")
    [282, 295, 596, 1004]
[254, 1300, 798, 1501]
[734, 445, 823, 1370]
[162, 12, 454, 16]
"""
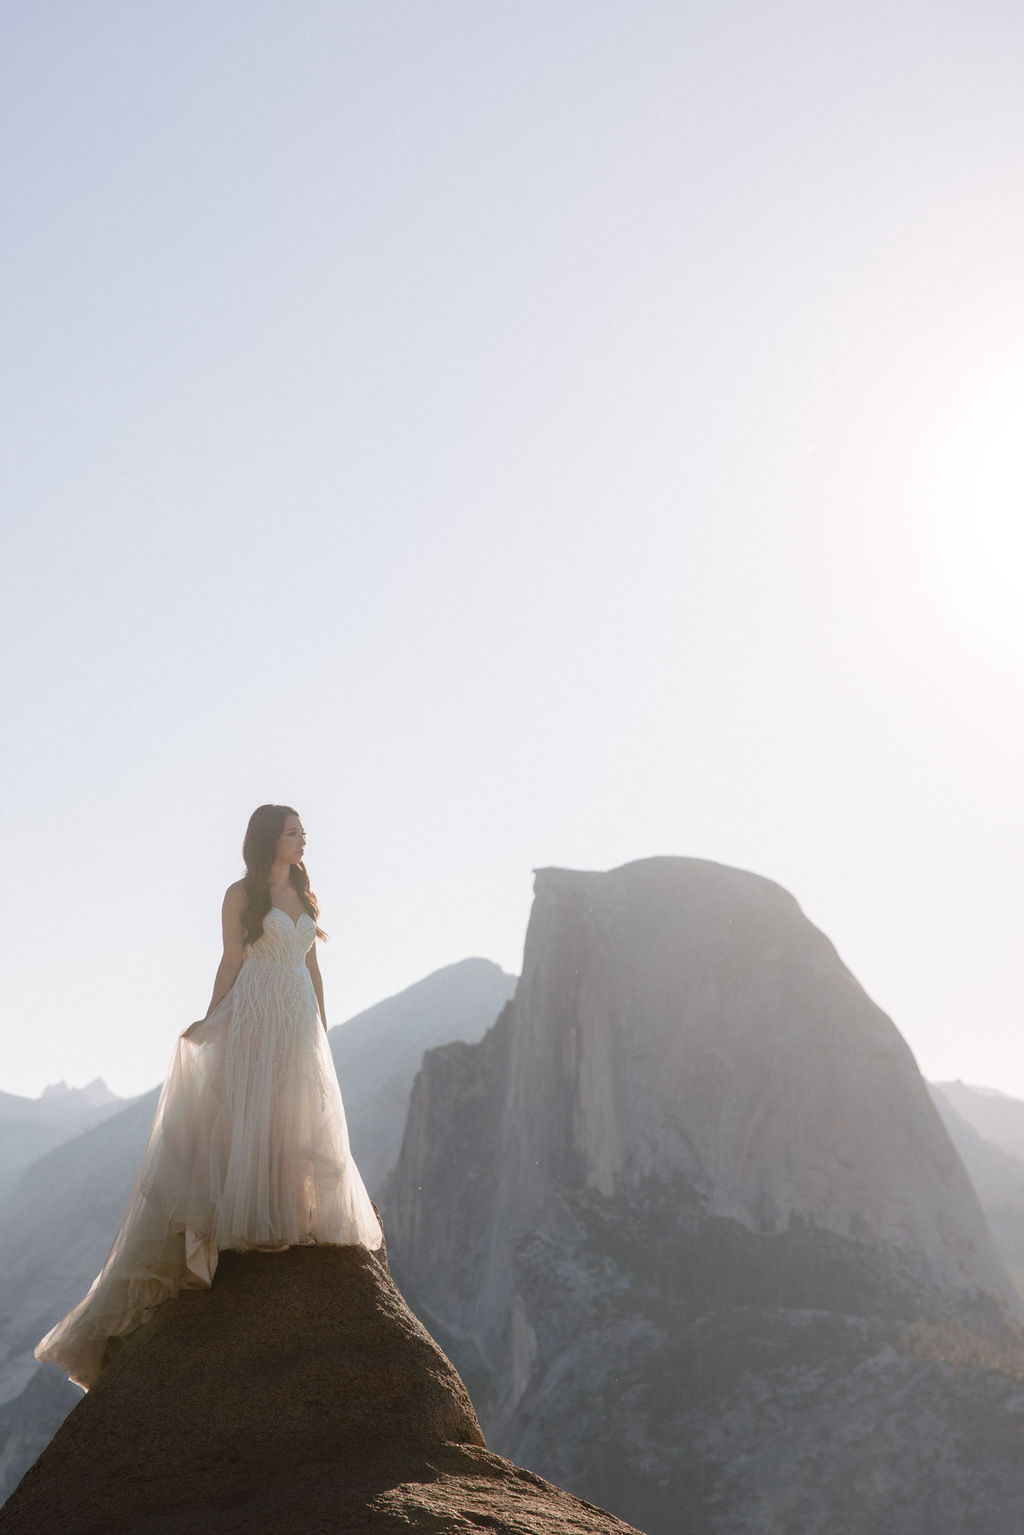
[35, 804, 381, 1391]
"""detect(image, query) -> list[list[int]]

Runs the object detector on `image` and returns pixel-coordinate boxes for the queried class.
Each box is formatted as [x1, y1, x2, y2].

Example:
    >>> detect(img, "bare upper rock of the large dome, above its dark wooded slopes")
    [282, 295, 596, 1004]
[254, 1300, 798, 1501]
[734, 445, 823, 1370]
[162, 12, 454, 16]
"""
[504, 857, 1018, 1306]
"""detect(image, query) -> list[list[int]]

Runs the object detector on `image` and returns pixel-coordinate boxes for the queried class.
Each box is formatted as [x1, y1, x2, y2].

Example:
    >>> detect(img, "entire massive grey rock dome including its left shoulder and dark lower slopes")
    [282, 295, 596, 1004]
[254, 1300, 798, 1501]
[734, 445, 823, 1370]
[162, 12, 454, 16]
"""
[390, 858, 1024, 1535]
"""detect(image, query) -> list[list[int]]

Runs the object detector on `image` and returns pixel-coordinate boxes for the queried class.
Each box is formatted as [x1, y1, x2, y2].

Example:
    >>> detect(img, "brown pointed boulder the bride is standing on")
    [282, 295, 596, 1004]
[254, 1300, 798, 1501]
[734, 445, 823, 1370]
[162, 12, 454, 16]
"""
[0, 1248, 641, 1535]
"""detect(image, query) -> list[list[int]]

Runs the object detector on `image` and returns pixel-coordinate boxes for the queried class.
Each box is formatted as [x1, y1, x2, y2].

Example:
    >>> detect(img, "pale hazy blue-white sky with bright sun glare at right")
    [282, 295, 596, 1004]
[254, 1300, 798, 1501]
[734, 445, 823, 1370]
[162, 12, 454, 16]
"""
[0, 0, 1024, 1096]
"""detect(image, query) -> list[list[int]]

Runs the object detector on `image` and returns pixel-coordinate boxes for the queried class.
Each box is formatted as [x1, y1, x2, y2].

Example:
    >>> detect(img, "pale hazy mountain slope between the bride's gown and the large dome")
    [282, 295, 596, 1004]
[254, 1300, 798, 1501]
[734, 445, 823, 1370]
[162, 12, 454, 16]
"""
[327, 959, 516, 1203]
